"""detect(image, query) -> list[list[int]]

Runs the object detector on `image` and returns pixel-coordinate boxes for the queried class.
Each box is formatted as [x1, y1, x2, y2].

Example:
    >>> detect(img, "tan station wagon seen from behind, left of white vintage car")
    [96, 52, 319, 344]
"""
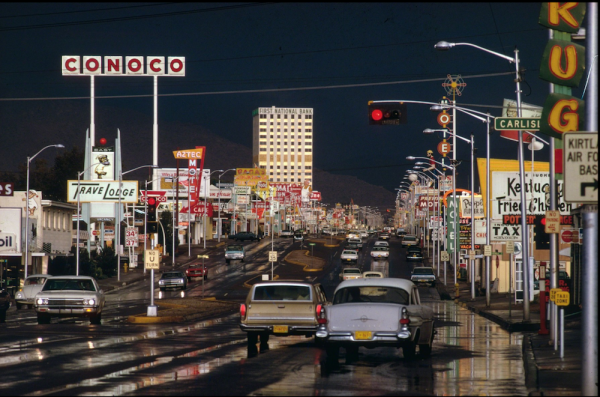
[240, 280, 327, 345]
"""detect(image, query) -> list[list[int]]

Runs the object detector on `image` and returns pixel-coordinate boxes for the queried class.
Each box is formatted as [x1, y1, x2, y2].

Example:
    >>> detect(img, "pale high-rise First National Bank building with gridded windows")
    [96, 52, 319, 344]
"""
[252, 106, 313, 183]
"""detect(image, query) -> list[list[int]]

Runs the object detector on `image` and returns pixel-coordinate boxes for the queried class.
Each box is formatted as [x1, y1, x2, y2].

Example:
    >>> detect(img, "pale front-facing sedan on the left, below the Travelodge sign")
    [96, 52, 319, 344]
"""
[34, 276, 106, 325]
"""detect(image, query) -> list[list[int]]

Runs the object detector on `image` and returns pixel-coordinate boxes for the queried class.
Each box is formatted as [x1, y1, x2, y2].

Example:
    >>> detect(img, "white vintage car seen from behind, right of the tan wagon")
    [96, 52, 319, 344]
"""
[316, 278, 435, 361]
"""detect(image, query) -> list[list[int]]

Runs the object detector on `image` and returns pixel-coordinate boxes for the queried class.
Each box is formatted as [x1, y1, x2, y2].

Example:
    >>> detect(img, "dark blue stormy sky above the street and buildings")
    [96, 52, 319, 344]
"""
[0, 3, 581, 191]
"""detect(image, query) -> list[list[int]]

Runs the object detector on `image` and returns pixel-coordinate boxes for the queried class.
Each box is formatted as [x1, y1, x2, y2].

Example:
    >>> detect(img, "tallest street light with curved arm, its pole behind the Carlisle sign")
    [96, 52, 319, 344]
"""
[434, 41, 530, 321]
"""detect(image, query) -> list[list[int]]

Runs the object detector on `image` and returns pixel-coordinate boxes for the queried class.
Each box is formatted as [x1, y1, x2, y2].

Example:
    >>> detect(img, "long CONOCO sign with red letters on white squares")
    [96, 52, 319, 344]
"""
[61, 55, 185, 77]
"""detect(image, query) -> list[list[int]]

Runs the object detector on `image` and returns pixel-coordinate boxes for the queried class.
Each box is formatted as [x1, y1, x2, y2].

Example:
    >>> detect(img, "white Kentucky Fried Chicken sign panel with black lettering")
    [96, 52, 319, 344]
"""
[491, 171, 577, 220]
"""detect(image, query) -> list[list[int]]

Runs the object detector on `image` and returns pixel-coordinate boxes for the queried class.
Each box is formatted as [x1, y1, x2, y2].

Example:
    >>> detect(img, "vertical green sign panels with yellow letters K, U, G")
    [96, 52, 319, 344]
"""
[539, 2, 586, 139]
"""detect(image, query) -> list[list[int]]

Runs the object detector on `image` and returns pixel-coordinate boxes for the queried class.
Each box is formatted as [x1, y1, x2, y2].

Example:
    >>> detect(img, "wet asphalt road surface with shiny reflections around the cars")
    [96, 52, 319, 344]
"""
[0, 234, 527, 395]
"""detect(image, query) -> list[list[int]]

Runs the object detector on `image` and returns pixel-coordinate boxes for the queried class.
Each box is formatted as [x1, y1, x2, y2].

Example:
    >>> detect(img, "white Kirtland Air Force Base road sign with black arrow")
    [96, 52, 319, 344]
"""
[563, 131, 598, 203]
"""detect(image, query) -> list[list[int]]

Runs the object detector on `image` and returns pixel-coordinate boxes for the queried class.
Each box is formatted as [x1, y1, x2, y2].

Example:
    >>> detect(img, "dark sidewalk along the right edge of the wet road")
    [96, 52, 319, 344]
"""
[428, 255, 582, 396]
